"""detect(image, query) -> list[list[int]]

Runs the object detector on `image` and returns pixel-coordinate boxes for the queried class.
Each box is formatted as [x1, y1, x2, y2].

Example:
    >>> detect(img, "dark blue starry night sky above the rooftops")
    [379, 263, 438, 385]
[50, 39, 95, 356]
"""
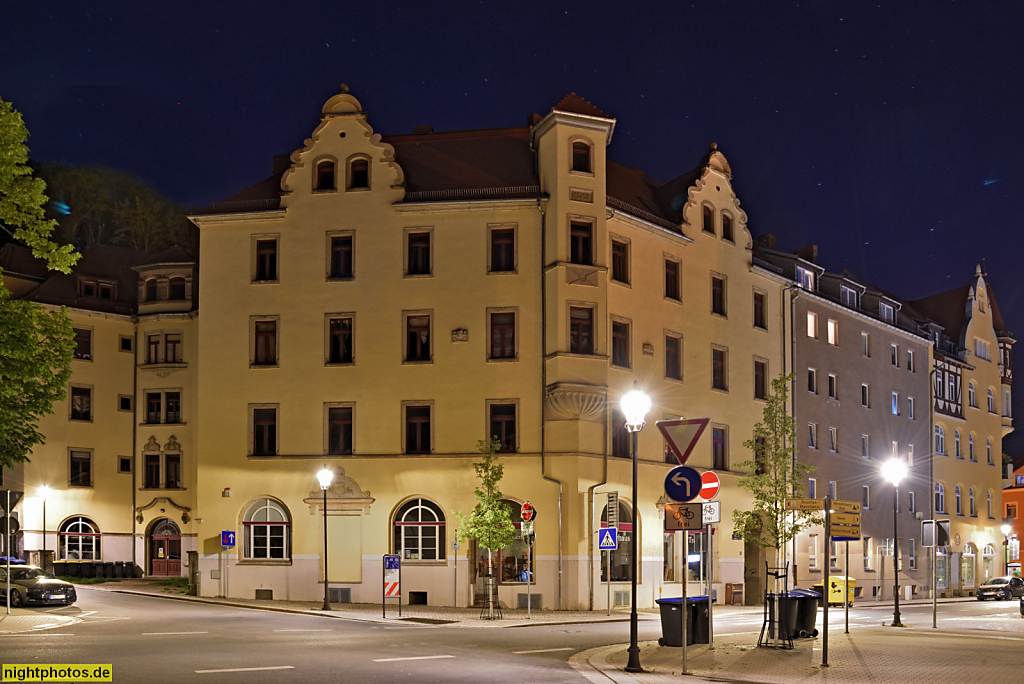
[6, 0, 1024, 455]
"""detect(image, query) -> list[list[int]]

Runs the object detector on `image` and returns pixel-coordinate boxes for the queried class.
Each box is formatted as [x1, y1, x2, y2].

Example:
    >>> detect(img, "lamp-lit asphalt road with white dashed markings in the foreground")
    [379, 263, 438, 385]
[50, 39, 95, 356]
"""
[0, 588, 1024, 684]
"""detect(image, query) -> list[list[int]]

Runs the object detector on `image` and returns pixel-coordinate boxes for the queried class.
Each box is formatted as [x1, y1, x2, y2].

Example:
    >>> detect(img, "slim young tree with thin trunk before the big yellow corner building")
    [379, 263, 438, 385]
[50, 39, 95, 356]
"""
[456, 437, 518, 618]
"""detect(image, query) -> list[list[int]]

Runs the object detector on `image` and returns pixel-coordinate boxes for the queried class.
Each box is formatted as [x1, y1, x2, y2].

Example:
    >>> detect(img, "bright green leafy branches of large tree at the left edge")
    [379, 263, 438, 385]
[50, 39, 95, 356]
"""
[0, 99, 79, 468]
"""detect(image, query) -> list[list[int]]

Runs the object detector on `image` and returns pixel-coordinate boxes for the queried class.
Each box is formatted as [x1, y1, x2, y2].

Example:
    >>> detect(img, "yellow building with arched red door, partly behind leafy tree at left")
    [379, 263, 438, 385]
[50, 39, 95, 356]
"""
[0, 245, 198, 575]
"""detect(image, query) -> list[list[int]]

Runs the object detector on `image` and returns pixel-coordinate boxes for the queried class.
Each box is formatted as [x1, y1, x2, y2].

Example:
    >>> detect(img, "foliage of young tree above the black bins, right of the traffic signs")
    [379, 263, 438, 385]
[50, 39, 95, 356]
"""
[732, 374, 818, 554]
